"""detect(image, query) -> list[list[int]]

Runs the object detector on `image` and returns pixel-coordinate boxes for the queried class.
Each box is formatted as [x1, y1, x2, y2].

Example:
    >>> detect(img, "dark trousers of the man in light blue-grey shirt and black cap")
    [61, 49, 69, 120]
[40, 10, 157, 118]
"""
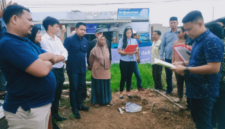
[165, 59, 173, 94]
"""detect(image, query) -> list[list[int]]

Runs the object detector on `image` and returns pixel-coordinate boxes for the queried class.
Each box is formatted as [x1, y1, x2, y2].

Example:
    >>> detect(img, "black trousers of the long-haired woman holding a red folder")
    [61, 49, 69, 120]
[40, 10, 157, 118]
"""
[120, 60, 136, 92]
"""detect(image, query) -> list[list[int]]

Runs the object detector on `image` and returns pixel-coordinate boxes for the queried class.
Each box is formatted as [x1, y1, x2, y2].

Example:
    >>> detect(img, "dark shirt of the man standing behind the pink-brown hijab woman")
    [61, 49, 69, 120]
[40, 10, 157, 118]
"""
[87, 39, 112, 65]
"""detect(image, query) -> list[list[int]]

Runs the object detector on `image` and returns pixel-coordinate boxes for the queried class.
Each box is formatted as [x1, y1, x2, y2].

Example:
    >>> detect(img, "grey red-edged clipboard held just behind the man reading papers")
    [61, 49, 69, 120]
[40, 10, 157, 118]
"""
[173, 45, 190, 61]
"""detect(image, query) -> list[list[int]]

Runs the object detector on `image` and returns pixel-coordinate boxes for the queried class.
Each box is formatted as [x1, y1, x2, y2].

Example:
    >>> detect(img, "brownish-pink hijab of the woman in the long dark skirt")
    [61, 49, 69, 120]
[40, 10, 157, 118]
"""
[93, 36, 110, 70]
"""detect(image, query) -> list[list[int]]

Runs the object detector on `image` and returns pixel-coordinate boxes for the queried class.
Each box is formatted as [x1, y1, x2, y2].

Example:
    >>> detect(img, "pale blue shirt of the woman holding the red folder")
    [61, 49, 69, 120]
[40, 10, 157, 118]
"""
[118, 38, 138, 62]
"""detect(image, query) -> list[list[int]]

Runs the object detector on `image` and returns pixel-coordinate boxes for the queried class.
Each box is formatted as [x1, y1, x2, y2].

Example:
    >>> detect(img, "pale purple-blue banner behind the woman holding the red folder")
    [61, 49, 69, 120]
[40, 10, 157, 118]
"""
[111, 46, 151, 64]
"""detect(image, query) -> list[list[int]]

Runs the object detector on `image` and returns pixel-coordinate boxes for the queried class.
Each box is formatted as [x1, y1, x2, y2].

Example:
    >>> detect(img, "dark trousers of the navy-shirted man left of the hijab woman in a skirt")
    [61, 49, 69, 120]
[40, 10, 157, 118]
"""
[67, 70, 86, 111]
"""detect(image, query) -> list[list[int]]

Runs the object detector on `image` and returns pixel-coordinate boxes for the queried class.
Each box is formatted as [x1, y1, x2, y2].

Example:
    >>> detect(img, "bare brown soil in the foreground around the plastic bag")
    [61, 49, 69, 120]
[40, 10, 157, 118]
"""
[58, 90, 195, 129]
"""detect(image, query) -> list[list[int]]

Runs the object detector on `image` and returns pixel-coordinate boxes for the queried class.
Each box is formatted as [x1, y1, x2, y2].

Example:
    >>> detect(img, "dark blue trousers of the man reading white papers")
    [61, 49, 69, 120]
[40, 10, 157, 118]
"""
[190, 97, 216, 129]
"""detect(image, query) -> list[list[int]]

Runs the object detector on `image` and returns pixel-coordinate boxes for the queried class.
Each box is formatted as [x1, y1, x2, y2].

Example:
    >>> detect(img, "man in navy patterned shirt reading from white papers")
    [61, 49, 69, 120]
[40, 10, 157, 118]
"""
[172, 11, 224, 129]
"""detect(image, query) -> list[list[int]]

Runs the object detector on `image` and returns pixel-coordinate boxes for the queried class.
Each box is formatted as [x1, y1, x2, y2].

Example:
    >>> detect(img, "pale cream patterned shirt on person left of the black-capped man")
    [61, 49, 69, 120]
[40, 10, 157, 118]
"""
[151, 40, 161, 65]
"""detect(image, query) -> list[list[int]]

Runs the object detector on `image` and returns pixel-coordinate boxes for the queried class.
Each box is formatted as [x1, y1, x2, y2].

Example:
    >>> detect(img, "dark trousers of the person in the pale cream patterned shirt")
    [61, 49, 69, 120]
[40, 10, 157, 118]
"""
[152, 65, 163, 90]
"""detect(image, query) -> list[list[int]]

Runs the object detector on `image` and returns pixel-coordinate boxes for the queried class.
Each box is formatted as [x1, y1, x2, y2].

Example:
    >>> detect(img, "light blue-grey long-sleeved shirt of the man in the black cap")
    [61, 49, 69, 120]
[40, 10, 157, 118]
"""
[160, 30, 178, 60]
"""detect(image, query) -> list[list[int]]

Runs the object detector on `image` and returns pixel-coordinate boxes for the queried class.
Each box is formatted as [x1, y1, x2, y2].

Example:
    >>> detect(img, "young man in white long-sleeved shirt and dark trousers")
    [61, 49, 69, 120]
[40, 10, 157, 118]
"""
[41, 17, 68, 128]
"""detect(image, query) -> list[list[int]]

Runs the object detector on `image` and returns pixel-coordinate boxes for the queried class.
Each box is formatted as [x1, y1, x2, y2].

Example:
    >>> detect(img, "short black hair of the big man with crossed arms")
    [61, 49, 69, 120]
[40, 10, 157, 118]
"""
[3, 4, 30, 24]
